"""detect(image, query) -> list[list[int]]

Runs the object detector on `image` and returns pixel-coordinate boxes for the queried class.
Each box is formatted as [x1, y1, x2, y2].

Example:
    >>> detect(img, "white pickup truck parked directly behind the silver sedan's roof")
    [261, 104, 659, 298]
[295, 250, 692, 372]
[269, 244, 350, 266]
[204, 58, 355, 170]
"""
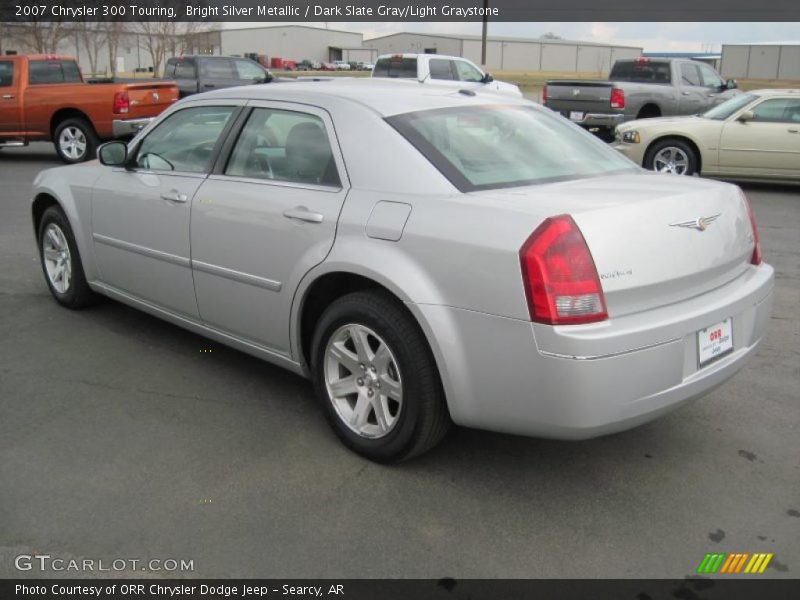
[372, 53, 522, 97]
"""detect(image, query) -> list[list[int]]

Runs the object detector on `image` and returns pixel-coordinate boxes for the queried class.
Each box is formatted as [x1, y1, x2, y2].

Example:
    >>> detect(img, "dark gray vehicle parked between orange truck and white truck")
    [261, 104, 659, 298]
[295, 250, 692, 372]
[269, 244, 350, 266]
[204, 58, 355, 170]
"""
[164, 55, 273, 98]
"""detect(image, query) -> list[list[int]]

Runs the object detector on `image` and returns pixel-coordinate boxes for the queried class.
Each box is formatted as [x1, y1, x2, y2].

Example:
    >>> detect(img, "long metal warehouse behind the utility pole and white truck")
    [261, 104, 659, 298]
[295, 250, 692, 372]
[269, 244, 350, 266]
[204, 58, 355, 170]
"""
[364, 33, 642, 73]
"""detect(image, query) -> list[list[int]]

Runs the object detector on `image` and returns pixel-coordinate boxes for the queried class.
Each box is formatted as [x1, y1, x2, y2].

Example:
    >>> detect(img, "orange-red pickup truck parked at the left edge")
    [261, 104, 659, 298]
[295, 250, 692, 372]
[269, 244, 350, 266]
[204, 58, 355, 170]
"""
[0, 55, 178, 163]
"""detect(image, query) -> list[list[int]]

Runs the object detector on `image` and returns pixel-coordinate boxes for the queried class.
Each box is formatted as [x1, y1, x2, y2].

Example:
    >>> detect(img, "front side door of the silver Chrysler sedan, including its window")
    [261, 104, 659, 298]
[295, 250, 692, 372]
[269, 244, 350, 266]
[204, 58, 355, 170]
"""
[92, 103, 238, 317]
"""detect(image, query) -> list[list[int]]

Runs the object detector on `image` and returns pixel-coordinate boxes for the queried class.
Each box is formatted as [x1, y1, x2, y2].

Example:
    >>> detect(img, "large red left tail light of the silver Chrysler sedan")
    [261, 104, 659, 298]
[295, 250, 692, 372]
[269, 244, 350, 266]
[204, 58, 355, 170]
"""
[519, 215, 608, 325]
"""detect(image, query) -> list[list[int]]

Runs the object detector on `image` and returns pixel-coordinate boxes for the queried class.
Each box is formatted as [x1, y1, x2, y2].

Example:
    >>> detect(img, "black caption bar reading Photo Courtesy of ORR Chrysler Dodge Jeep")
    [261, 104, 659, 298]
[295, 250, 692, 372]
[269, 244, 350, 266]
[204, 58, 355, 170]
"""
[0, 576, 800, 600]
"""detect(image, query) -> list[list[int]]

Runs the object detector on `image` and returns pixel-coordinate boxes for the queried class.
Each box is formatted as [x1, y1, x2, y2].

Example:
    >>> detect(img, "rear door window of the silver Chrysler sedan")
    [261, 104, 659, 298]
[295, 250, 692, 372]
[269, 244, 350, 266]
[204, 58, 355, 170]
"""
[225, 108, 341, 187]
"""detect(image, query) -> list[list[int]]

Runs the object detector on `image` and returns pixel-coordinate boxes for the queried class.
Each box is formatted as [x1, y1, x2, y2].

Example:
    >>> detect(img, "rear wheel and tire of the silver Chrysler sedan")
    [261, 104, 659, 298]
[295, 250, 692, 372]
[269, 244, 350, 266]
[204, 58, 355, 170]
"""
[312, 291, 450, 463]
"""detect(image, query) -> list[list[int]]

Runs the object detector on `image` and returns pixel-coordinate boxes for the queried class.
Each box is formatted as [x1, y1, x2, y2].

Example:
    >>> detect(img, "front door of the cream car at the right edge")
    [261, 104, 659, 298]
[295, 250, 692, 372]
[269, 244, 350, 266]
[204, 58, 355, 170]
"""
[719, 97, 800, 177]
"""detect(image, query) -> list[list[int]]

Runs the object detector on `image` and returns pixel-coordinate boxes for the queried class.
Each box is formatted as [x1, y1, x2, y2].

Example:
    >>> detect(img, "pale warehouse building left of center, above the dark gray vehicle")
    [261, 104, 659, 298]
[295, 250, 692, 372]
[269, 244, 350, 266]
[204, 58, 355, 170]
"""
[219, 25, 371, 61]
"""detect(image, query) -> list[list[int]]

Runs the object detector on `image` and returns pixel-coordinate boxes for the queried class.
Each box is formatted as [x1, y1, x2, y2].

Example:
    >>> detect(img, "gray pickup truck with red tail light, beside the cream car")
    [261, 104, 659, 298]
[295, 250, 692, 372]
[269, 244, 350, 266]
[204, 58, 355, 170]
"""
[542, 58, 741, 138]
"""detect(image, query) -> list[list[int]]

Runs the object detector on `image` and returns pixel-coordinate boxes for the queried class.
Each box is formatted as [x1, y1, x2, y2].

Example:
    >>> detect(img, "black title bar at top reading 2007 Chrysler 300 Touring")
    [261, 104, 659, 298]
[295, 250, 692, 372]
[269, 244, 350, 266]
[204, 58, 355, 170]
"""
[0, 0, 800, 22]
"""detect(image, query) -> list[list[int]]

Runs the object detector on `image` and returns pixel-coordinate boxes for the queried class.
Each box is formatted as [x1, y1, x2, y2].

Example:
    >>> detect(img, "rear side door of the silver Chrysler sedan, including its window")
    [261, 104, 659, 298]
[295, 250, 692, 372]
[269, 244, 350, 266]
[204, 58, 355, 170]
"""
[191, 102, 348, 355]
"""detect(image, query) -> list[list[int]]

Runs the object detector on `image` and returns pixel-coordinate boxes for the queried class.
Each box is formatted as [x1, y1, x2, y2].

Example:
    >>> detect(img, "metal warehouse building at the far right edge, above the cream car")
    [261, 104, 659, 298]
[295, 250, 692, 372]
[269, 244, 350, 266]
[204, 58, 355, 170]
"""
[721, 42, 800, 81]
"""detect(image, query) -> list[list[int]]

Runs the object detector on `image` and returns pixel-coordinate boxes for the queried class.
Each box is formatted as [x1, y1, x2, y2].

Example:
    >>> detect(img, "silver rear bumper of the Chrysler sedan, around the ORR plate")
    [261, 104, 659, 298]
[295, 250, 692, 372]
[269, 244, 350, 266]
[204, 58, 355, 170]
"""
[414, 264, 774, 439]
